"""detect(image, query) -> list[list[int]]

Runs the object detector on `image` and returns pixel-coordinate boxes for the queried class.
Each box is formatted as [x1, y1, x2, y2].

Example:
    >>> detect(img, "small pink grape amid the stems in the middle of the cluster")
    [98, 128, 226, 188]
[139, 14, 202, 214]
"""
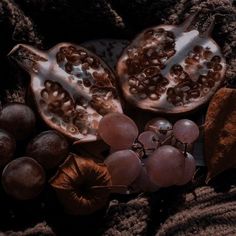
[138, 130, 158, 155]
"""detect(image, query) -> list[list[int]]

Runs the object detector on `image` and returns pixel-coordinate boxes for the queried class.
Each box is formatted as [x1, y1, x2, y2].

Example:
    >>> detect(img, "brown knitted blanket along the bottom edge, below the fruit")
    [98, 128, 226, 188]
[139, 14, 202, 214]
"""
[0, 183, 236, 236]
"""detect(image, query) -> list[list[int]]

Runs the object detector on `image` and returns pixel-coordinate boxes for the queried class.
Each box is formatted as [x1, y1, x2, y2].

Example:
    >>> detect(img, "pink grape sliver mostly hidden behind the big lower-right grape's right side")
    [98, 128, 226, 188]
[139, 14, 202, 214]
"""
[177, 152, 196, 185]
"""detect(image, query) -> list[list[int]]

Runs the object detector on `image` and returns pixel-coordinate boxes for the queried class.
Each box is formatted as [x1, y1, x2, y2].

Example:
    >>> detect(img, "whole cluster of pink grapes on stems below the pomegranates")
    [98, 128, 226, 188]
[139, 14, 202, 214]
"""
[98, 113, 199, 192]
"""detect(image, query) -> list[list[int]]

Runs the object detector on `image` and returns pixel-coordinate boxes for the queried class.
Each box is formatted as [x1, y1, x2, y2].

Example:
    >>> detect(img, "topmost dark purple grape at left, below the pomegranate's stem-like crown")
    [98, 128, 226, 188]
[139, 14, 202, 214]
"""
[0, 103, 36, 140]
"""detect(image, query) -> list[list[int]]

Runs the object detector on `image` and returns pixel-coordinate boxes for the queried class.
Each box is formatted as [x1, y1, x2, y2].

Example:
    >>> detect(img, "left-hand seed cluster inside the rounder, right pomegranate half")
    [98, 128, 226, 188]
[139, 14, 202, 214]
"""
[125, 28, 175, 100]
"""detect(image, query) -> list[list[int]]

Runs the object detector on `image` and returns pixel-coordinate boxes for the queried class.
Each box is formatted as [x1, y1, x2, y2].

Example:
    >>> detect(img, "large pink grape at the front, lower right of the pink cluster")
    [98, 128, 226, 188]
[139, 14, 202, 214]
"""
[146, 145, 185, 187]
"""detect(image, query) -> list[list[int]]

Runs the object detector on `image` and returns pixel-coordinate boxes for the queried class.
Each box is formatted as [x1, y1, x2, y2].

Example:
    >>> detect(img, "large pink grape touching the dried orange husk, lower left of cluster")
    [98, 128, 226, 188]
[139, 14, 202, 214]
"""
[104, 150, 142, 186]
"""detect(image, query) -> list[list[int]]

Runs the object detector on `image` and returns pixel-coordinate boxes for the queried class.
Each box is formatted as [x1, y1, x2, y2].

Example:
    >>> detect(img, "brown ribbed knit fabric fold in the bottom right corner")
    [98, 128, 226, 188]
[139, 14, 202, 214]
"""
[156, 187, 236, 236]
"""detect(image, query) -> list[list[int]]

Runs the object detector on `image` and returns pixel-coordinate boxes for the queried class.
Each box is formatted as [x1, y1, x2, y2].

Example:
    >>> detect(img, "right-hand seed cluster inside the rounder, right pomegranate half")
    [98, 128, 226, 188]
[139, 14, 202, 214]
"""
[167, 45, 223, 106]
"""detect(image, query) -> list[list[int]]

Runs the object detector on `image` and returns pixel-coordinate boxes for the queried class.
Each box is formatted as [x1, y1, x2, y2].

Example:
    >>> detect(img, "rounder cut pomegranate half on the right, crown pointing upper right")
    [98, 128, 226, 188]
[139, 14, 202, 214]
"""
[117, 14, 226, 114]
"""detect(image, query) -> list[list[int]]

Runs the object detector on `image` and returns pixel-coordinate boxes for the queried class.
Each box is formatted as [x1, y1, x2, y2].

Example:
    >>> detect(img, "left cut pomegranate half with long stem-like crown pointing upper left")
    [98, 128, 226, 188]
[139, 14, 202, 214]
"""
[10, 43, 122, 142]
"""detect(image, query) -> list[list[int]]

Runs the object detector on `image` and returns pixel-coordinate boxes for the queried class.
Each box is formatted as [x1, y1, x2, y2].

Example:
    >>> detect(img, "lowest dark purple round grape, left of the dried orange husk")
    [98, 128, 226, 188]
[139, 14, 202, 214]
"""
[2, 157, 45, 200]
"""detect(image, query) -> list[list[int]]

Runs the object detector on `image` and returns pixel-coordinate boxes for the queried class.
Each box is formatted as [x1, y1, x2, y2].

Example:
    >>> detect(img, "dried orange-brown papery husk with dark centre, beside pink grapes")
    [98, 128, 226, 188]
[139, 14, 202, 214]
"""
[50, 154, 111, 215]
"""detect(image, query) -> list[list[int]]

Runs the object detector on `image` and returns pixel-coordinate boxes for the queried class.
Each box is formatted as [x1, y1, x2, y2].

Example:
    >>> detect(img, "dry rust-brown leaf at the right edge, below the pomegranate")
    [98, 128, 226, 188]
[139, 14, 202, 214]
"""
[205, 88, 236, 183]
